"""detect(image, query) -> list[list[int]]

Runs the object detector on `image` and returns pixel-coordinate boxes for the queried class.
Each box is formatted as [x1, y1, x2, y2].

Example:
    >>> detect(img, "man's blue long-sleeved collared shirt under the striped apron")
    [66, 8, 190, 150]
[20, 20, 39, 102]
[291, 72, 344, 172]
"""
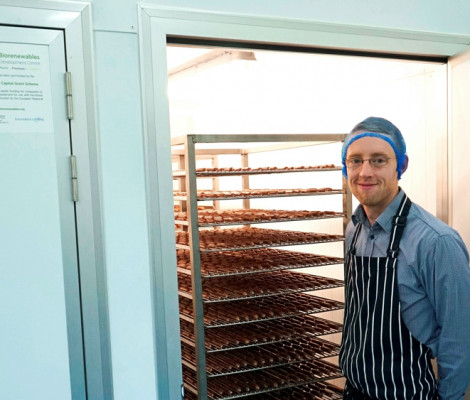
[346, 190, 470, 400]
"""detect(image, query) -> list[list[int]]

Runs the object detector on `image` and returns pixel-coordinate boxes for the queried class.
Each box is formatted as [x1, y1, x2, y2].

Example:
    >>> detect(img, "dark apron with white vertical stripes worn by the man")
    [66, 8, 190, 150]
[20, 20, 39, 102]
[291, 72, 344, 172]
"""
[339, 195, 437, 400]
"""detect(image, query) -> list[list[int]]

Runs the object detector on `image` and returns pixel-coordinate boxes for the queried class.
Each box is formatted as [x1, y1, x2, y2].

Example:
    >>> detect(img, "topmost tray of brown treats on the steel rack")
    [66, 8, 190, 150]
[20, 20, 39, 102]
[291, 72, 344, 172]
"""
[173, 164, 341, 177]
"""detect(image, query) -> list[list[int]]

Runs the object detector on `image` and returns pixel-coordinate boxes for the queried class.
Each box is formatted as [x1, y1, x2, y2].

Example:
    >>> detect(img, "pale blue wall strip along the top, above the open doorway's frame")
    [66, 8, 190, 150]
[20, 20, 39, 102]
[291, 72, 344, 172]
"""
[87, 0, 470, 34]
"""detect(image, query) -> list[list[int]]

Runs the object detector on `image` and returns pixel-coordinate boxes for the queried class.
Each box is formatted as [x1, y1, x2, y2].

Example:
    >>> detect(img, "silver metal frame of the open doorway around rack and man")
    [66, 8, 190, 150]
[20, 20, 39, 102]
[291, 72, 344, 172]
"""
[138, 4, 470, 398]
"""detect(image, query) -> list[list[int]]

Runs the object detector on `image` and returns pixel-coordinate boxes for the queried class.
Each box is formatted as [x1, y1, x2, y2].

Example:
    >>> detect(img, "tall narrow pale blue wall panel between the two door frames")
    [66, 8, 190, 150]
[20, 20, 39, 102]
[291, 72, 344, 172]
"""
[95, 32, 156, 400]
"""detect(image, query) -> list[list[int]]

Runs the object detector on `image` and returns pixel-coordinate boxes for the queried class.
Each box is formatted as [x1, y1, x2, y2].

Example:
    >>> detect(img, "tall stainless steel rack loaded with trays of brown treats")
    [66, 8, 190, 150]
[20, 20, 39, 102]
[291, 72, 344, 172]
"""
[172, 134, 351, 400]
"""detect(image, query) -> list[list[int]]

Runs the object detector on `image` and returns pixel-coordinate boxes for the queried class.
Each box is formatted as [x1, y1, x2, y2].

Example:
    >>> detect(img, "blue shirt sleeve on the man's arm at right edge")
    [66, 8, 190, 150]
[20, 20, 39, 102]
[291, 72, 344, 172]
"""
[422, 234, 470, 400]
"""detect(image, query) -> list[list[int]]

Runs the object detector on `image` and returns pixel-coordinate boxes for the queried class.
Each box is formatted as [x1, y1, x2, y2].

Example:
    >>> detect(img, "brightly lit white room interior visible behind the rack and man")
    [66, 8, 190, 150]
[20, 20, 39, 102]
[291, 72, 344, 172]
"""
[167, 43, 447, 393]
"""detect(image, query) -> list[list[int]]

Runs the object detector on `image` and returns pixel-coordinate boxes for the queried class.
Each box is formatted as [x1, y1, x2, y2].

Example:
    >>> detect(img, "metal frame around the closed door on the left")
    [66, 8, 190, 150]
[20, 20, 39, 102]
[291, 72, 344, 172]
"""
[0, 0, 113, 400]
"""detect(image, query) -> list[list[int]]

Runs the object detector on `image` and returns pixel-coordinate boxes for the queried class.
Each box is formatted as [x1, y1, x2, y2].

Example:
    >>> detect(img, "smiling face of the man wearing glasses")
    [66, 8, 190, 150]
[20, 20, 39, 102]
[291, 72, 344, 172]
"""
[346, 136, 398, 217]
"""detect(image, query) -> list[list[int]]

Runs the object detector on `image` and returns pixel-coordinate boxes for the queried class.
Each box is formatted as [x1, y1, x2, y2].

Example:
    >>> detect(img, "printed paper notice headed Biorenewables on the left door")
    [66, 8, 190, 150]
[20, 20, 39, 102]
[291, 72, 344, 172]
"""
[0, 42, 53, 133]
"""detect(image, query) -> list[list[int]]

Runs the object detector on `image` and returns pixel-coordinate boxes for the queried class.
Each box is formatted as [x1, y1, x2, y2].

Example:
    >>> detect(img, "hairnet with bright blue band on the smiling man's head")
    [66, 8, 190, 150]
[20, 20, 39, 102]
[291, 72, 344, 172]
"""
[341, 117, 408, 179]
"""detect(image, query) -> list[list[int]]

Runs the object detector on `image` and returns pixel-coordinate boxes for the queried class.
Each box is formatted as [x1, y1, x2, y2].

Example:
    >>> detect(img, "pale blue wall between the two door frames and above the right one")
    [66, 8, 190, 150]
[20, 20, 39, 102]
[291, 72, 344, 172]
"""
[81, 0, 470, 400]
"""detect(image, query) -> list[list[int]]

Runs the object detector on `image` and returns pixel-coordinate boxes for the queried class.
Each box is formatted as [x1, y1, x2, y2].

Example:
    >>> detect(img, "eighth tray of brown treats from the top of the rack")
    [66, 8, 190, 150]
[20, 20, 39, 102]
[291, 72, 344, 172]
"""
[180, 315, 343, 353]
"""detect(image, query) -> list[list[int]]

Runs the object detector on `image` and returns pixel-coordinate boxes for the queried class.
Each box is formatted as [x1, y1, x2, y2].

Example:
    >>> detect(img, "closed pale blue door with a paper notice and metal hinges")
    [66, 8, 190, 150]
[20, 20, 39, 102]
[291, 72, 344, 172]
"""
[0, 26, 86, 400]
